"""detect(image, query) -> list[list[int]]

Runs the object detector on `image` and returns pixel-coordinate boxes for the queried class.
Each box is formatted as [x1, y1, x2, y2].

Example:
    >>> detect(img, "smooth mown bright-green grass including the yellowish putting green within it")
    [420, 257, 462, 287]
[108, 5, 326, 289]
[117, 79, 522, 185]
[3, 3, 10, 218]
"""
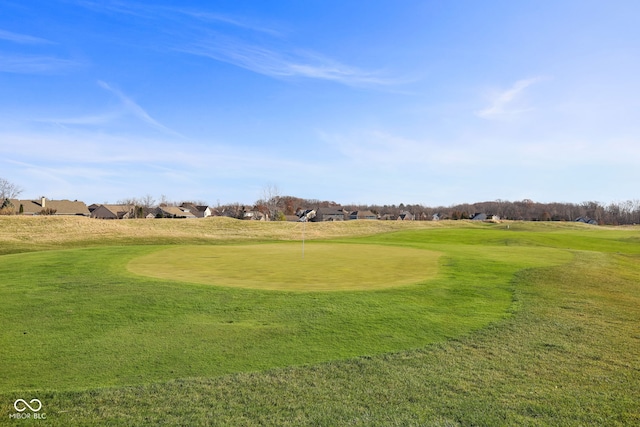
[0, 223, 571, 390]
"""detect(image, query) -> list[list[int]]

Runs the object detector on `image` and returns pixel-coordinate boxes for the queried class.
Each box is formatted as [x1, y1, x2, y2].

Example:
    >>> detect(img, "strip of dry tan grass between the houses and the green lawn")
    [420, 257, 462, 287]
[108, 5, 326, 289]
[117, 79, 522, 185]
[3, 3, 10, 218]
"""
[0, 216, 444, 252]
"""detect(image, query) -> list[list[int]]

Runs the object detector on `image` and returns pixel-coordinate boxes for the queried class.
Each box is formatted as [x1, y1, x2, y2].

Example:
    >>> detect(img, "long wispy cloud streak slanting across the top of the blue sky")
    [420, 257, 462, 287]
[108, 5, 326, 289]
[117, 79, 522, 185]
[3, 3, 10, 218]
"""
[75, 1, 396, 87]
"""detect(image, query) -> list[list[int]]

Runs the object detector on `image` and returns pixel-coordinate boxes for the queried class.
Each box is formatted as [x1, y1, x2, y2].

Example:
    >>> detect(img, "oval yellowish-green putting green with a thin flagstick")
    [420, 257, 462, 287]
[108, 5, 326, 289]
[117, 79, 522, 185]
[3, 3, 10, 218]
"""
[128, 243, 440, 291]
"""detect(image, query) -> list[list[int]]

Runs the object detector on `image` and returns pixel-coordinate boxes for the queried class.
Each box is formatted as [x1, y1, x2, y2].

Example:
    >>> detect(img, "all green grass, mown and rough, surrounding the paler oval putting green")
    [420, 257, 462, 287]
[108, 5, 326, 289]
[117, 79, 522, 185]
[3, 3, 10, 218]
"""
[0, 219, 640, 425]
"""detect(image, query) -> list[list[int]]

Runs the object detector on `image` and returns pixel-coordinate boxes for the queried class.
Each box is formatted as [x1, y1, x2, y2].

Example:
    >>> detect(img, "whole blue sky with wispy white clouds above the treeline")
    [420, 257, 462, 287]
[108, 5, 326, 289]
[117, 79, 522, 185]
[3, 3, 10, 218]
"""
[0, 0, 640, 206]
